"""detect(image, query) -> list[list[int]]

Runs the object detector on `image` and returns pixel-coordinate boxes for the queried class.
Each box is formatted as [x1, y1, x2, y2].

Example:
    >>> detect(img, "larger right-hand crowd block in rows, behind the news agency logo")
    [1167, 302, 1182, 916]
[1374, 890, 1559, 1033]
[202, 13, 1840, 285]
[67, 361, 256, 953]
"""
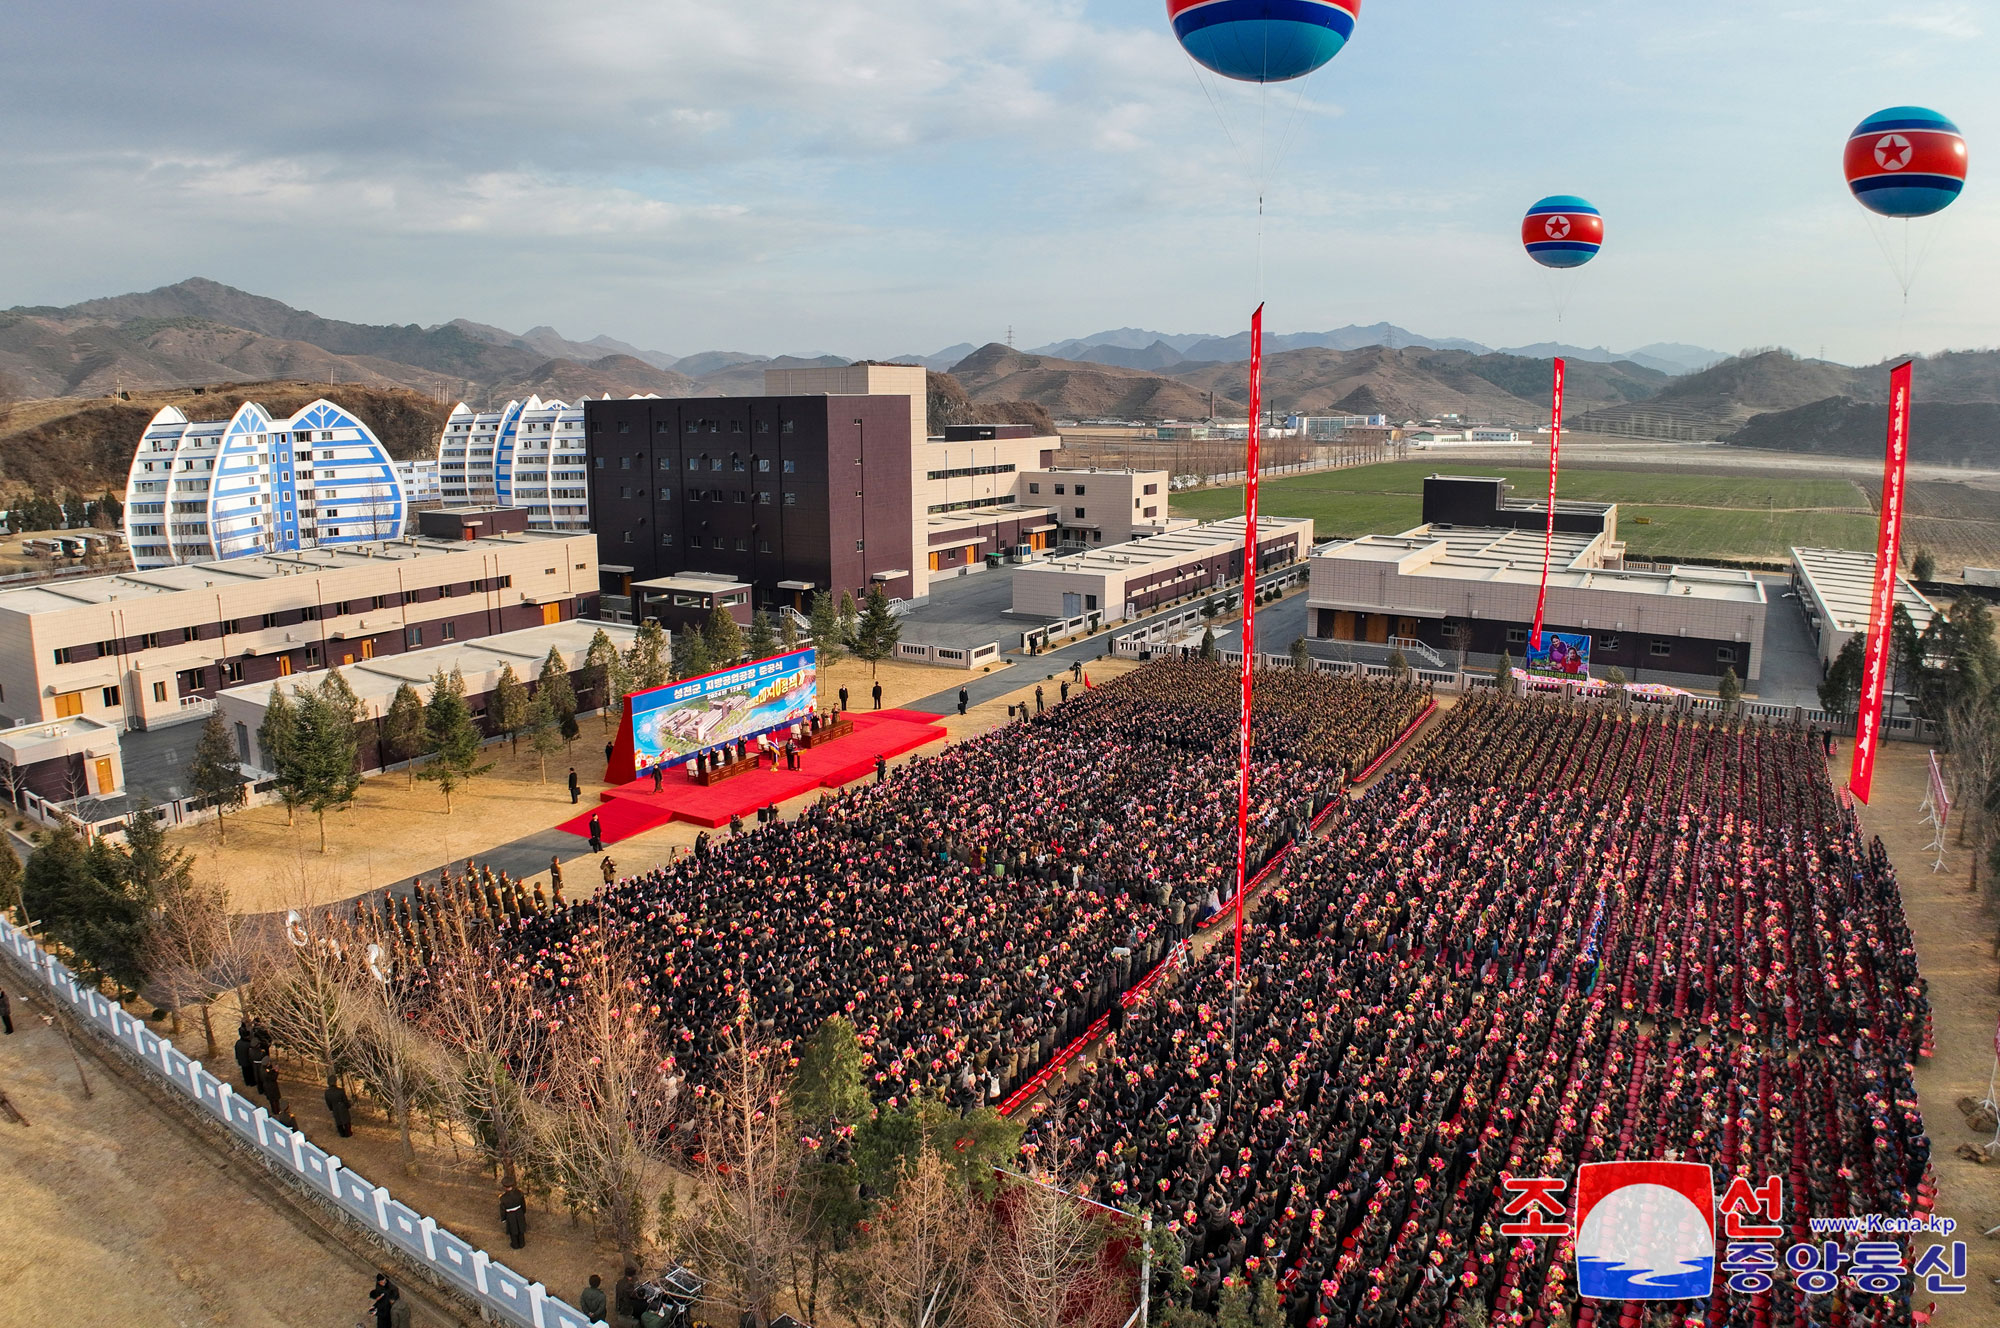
[1028, 698, 1928, 1328]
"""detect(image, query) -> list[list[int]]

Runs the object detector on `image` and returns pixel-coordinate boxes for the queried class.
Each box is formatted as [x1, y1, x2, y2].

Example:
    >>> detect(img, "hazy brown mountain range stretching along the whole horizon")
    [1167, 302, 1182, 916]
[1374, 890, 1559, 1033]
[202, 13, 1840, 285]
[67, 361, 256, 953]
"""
[0, 278, 2000, 478]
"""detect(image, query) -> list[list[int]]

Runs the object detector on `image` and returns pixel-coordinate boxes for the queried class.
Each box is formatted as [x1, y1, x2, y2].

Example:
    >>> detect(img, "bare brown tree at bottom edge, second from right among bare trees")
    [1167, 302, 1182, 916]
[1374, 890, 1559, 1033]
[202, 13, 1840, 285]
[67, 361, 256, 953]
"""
[854, 1148, 992, 1328]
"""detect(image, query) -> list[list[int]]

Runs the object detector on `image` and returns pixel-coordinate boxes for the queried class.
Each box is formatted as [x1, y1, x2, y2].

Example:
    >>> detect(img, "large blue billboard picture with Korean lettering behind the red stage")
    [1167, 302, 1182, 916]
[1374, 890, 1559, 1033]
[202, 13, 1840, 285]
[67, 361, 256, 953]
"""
[628, 650, 820, 770]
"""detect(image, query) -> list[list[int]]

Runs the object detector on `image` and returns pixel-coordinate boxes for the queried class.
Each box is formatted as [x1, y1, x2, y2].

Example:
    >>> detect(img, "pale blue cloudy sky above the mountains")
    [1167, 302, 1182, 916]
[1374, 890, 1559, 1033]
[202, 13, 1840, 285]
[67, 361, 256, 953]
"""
[0, 0, 2000, 364]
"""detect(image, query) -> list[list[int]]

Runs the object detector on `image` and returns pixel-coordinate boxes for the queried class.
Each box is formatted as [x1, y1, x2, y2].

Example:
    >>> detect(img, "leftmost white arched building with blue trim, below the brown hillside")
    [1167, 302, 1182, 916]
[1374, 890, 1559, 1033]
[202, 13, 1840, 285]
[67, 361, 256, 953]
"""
[124, 398, 406, 572]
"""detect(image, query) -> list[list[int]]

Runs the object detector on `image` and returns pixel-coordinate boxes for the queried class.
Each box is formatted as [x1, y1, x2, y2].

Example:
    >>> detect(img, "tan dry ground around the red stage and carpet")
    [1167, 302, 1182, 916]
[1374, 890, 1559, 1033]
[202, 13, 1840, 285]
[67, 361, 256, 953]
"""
[172, 644, 1032, 912]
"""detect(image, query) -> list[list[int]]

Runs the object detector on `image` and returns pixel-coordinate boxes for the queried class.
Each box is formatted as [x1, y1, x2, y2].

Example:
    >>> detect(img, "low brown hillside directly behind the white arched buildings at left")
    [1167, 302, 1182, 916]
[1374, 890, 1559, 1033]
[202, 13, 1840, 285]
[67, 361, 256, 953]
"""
[0, 382, 450, 506]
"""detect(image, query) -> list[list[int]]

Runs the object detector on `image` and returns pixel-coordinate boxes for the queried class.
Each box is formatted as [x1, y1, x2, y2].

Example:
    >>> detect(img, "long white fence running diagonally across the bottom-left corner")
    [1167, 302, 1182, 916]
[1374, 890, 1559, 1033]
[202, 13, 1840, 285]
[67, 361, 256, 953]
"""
[0, 918, 592, 1328]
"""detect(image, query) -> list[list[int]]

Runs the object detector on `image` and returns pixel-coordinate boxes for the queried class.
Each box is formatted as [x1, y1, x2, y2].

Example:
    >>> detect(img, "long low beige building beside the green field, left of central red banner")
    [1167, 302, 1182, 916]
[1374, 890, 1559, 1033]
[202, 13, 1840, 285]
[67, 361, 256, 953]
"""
[1014, 516, 1312, 622]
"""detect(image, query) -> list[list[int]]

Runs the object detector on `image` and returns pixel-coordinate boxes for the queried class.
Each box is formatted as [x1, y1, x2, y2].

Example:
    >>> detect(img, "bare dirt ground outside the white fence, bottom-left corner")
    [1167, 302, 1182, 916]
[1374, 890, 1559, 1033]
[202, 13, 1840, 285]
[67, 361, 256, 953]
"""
[0, 980, 370, 1328]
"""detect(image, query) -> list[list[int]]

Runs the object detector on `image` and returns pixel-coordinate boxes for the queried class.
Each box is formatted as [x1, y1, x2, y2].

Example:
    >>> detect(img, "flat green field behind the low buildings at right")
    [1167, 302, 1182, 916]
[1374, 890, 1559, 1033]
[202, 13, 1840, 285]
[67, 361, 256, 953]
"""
[1172, 462, 1876, 558]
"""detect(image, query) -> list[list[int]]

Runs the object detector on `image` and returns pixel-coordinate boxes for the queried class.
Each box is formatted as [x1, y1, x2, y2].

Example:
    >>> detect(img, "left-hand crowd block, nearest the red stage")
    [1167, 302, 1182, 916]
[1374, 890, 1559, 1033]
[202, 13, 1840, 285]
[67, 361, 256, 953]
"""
[376, 662, 1428, 1108]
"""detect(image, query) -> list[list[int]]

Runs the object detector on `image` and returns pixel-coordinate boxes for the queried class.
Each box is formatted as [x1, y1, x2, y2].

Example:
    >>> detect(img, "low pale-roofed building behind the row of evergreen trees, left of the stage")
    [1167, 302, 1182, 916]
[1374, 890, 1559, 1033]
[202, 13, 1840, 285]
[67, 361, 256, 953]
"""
[216, 620, 636, 774]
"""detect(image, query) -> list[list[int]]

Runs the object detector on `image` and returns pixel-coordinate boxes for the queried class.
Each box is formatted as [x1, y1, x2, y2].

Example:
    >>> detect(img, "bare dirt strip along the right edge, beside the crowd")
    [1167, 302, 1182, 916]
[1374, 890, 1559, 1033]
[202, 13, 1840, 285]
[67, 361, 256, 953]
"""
[1832, 742, 2000, 1328]
